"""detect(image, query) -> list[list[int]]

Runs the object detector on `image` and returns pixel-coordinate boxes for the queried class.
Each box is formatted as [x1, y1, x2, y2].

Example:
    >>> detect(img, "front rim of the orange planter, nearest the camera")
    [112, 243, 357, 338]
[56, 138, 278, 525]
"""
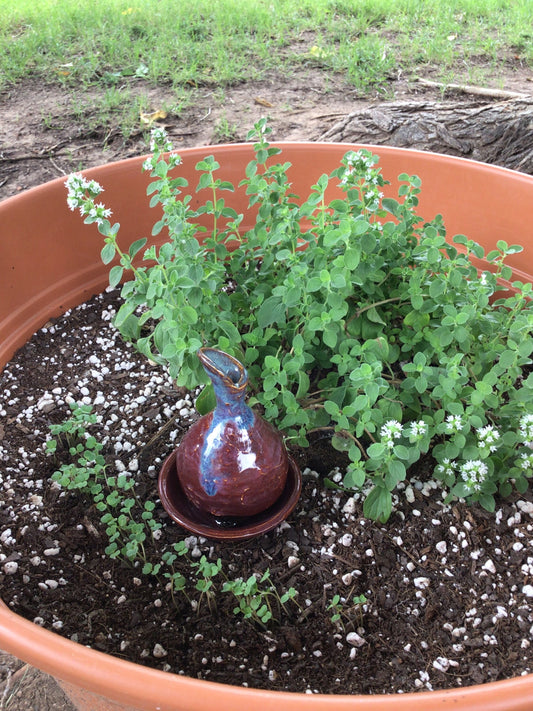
[0, 600, 533, 711]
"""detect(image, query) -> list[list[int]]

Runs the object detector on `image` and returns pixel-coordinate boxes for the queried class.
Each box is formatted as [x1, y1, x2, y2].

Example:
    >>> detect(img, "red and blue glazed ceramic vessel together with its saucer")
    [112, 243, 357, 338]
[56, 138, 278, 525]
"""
[159, 348, 301, 539]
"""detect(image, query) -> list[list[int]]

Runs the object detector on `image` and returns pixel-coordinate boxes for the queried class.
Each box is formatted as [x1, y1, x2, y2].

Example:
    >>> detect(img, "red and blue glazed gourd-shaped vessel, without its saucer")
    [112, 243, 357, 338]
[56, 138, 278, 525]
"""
[176, 348, 289, 518]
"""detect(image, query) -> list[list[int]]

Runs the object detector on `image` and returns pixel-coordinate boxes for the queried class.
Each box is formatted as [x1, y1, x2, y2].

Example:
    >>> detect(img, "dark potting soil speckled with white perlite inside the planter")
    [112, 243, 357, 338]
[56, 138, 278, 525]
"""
[0, 292, 533, 694]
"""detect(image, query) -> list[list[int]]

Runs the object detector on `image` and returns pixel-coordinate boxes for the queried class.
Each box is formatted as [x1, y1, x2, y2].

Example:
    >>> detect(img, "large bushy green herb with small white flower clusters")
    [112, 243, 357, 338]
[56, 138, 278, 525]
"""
[66, 119, 533, 521]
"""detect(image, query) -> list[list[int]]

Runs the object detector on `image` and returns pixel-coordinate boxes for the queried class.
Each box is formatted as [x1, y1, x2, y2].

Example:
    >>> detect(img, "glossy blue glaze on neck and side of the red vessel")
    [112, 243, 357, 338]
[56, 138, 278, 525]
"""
[200, 348, 255, 496]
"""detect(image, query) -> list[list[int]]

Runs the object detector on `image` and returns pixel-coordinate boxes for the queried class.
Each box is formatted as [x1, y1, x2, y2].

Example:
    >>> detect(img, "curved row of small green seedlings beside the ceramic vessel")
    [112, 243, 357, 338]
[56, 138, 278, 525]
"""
[45, 403, 298, 627]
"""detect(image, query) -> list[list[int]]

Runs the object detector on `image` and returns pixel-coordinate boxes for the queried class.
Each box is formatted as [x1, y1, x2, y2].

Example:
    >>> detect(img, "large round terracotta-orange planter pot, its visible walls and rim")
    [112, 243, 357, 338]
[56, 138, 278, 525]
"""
[0, 143, 533, 711]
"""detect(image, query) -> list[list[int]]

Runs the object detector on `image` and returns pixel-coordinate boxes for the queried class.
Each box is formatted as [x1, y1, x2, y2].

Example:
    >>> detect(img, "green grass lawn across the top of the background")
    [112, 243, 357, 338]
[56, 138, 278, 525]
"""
[0, 0, 533, 92]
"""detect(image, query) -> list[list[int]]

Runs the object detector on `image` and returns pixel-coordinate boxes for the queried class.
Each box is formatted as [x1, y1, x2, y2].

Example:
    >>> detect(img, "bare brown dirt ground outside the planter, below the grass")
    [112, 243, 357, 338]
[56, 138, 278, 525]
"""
[0, 66, 533, 711]
